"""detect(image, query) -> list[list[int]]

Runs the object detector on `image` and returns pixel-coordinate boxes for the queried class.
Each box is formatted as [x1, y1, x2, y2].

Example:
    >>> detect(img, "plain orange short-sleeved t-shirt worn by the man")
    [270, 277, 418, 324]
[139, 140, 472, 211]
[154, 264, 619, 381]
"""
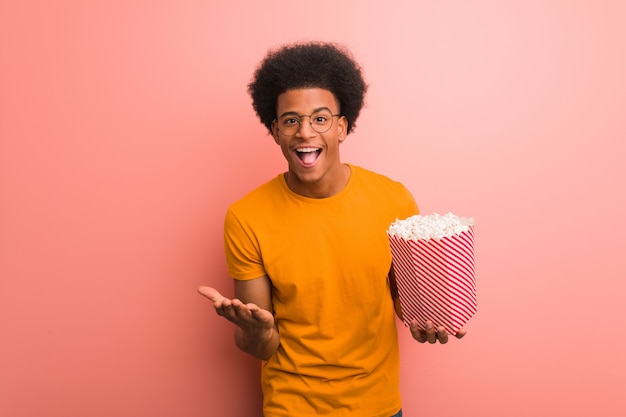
[224, 166, 418, 417]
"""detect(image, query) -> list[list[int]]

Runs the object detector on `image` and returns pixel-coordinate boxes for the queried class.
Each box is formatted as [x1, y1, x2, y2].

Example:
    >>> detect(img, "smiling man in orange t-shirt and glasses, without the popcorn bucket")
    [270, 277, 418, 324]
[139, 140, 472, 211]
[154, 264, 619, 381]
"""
[199, 43, 465, 417]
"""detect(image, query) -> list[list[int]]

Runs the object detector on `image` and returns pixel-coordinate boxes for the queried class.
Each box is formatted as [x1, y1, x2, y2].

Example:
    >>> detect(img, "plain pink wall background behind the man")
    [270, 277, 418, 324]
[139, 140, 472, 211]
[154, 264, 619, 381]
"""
[0, 0, 626, 417]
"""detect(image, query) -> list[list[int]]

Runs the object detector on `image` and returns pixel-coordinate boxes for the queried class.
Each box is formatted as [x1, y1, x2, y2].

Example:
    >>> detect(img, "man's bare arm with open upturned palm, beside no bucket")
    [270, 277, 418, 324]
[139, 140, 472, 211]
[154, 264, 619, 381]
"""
[198, 276, 280, 360]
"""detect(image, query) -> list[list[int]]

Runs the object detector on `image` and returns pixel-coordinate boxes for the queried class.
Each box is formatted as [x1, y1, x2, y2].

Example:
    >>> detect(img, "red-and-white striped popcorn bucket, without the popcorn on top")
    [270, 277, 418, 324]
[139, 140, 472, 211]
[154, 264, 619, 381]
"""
[388, 225, 476, 334]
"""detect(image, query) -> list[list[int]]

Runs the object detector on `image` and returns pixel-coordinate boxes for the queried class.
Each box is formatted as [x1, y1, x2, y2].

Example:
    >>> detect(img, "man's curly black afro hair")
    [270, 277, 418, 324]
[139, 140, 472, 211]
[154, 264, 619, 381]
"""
[248, 42, 367, 133]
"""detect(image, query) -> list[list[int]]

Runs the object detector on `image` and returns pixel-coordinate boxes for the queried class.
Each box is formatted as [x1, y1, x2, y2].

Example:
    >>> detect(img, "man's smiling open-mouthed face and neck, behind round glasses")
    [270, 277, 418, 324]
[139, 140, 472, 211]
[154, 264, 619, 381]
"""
[272, 88, 350, 198]
